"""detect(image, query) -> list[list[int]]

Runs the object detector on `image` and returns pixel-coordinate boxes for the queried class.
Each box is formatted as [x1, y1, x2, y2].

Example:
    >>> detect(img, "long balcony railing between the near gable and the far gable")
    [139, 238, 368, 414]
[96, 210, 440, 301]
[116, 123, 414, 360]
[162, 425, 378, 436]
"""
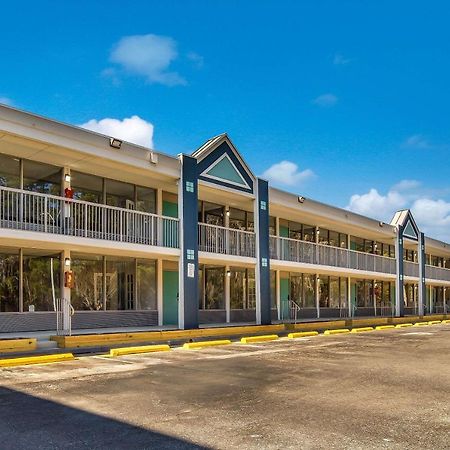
[270, 236, 395, 274]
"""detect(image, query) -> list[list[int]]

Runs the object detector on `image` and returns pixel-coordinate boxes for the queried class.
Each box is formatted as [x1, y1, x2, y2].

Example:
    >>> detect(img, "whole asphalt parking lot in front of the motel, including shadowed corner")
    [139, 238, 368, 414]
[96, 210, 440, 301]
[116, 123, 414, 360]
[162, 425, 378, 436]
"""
[0, 325, 450, 449]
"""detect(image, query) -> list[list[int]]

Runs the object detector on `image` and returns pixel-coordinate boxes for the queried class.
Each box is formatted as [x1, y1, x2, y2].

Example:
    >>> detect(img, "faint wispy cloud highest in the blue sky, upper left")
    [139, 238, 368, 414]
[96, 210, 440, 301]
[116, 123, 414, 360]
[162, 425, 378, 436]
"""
[110, 34, 186, 86]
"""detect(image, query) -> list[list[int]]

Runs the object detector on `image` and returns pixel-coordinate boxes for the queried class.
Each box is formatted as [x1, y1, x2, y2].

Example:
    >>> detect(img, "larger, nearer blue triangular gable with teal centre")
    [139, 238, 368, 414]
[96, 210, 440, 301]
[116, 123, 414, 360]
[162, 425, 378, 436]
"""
[192, 134, 255, 193]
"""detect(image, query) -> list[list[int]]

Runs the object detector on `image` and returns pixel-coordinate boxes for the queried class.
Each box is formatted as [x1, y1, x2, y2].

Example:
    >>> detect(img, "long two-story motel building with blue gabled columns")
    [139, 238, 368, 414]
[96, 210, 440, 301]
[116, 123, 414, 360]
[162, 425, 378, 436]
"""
[0, 106, 450, 332]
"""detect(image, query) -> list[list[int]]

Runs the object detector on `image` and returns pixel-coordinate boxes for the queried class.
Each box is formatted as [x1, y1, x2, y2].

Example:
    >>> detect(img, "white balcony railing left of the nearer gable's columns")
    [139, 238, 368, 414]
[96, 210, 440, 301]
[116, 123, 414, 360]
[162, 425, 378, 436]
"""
[0, 187, 179, 248]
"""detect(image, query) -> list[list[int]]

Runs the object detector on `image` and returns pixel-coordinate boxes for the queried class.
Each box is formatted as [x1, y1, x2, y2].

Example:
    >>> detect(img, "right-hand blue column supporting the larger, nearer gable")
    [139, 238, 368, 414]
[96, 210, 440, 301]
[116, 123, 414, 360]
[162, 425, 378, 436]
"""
[255, 178, 272, 325]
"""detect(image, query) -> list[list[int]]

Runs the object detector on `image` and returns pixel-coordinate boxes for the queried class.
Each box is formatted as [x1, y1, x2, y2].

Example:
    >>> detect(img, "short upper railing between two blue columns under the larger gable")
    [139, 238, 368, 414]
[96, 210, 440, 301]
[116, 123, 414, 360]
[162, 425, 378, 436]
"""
[198, 223, 255, 258]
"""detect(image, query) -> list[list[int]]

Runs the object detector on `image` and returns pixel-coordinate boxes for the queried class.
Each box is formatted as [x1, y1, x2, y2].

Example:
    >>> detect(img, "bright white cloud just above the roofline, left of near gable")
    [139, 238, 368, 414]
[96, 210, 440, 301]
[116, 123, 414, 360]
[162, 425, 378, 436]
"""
[80, 116, 154, 148]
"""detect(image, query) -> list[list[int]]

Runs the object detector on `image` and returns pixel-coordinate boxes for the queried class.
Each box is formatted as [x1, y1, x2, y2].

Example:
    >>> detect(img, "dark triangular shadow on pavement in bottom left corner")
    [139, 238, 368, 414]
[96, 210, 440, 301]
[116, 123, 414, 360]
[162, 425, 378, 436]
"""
[0, 387, 207, 450]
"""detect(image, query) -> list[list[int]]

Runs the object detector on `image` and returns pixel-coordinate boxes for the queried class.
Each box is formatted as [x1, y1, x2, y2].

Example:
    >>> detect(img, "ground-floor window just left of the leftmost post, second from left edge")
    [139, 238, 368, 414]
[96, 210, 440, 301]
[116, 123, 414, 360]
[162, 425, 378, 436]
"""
[23, 253, 60, 311]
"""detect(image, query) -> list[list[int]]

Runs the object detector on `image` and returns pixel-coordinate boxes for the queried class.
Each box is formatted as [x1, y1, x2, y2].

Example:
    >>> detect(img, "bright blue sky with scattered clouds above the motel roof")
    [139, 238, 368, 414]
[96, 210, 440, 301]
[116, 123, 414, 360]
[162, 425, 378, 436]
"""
[0, 0, 450, 241]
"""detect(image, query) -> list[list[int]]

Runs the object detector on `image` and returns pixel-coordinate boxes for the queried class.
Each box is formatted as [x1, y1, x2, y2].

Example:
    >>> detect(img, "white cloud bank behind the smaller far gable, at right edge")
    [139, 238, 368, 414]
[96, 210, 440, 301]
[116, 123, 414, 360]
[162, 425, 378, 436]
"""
[346, 180, 450, 242]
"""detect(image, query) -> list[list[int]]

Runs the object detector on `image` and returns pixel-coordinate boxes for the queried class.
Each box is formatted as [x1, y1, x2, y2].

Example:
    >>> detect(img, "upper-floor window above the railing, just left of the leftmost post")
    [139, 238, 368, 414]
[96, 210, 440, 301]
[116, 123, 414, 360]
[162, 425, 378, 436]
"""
[23, 159, 62, 195]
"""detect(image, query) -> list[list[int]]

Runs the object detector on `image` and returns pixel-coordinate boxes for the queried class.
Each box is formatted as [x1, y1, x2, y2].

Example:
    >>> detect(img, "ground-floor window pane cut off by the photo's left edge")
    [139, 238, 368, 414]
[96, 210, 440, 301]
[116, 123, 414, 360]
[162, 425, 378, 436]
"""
[0, 249, 19, 312]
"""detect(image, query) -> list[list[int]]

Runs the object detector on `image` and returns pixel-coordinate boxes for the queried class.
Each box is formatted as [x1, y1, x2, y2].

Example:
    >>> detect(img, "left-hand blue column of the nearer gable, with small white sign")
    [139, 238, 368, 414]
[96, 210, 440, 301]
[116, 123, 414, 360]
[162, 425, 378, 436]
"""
[178, 155, 198, 330]
